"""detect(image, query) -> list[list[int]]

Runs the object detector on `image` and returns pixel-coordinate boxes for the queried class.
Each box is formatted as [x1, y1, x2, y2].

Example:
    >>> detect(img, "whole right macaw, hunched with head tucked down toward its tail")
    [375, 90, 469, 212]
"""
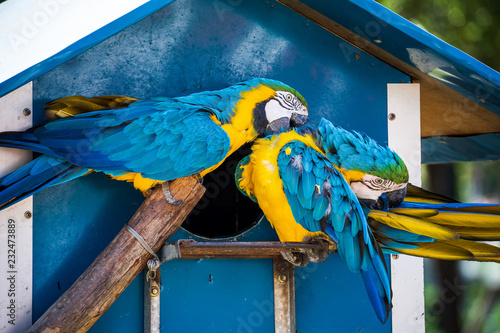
[235, 115, 500, 322]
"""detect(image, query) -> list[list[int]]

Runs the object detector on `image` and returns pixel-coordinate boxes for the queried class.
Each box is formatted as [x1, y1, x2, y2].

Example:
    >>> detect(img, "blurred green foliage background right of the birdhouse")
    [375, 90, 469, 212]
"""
[378, 0, 500, 333]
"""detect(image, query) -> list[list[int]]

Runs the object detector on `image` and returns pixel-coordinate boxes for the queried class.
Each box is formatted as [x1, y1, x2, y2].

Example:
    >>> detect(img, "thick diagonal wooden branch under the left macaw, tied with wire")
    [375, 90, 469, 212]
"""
[28, 177, 205, 333]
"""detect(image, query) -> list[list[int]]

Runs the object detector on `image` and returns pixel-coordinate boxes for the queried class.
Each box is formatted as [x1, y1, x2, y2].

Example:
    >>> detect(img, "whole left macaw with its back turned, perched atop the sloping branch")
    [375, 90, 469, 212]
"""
[0, 78, 308, 207]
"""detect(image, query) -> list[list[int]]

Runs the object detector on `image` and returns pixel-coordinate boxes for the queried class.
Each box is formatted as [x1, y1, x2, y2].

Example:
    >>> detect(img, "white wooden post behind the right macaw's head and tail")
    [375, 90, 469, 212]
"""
[387, 83, 425, 333]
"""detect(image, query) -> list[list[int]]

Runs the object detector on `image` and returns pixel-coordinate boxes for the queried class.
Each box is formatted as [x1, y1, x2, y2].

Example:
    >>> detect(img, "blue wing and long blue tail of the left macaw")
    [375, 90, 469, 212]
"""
[0, 97, 230, 207]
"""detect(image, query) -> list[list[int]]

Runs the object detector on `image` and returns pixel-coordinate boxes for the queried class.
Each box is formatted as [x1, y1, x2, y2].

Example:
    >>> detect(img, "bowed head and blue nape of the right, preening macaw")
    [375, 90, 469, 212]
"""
[317, 119, 409, 209]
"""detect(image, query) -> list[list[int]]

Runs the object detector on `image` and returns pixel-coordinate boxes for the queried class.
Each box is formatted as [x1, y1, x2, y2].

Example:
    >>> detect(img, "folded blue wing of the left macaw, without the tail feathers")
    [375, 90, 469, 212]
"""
[26, 99, 230, 180]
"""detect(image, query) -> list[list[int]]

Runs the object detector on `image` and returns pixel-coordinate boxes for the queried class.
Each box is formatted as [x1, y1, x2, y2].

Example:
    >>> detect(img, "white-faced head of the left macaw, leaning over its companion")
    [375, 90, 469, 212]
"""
[231, 78, 309, 135]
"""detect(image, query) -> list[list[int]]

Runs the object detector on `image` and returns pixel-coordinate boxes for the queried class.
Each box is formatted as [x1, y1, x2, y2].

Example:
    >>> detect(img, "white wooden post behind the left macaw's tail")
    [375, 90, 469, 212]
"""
[0, 82, 33, 333]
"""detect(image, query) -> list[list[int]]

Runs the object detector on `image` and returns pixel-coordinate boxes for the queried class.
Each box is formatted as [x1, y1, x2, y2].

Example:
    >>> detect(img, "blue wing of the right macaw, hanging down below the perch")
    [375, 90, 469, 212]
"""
[278, 141, 391, 322]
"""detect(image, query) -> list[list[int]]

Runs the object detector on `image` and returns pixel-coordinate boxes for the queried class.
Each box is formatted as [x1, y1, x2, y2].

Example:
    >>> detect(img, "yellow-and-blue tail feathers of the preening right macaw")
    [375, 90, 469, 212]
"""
[367, 185, 500, 262]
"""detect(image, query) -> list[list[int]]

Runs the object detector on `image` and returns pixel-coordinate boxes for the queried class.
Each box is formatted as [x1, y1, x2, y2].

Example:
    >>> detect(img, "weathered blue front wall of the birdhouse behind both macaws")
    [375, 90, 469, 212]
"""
[29, 0, 409, 332]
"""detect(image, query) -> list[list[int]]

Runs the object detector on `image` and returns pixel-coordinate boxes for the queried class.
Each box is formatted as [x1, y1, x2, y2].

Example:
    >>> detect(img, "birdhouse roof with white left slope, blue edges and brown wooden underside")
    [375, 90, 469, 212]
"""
[0, 0, 500, 163]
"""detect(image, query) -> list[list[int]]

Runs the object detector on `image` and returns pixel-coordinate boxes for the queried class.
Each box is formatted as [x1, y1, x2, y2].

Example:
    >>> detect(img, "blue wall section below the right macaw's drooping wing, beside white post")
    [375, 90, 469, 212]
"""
[295, 254, 392, 333]
